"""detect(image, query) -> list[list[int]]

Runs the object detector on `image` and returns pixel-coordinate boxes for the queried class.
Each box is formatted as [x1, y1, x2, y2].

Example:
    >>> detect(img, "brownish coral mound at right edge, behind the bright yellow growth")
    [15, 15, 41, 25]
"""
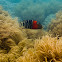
[48, 11, 62, 36]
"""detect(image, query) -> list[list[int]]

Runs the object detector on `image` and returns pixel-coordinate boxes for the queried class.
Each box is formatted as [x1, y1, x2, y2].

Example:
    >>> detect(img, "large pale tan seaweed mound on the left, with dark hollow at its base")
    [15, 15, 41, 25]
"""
[0, 8, 25, 52]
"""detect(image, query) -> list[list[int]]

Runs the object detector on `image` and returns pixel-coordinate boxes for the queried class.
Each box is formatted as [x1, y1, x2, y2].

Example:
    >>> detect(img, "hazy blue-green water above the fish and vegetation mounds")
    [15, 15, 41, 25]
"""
[0, 0, 62, 28]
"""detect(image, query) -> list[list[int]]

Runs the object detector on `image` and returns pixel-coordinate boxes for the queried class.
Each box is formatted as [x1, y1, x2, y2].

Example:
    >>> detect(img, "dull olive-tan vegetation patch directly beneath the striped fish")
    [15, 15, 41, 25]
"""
[22, 29, 47, 39]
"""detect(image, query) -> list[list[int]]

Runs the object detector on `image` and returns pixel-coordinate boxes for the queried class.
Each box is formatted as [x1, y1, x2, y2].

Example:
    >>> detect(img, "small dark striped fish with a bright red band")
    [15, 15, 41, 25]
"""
[20, 20, 42, 29]
